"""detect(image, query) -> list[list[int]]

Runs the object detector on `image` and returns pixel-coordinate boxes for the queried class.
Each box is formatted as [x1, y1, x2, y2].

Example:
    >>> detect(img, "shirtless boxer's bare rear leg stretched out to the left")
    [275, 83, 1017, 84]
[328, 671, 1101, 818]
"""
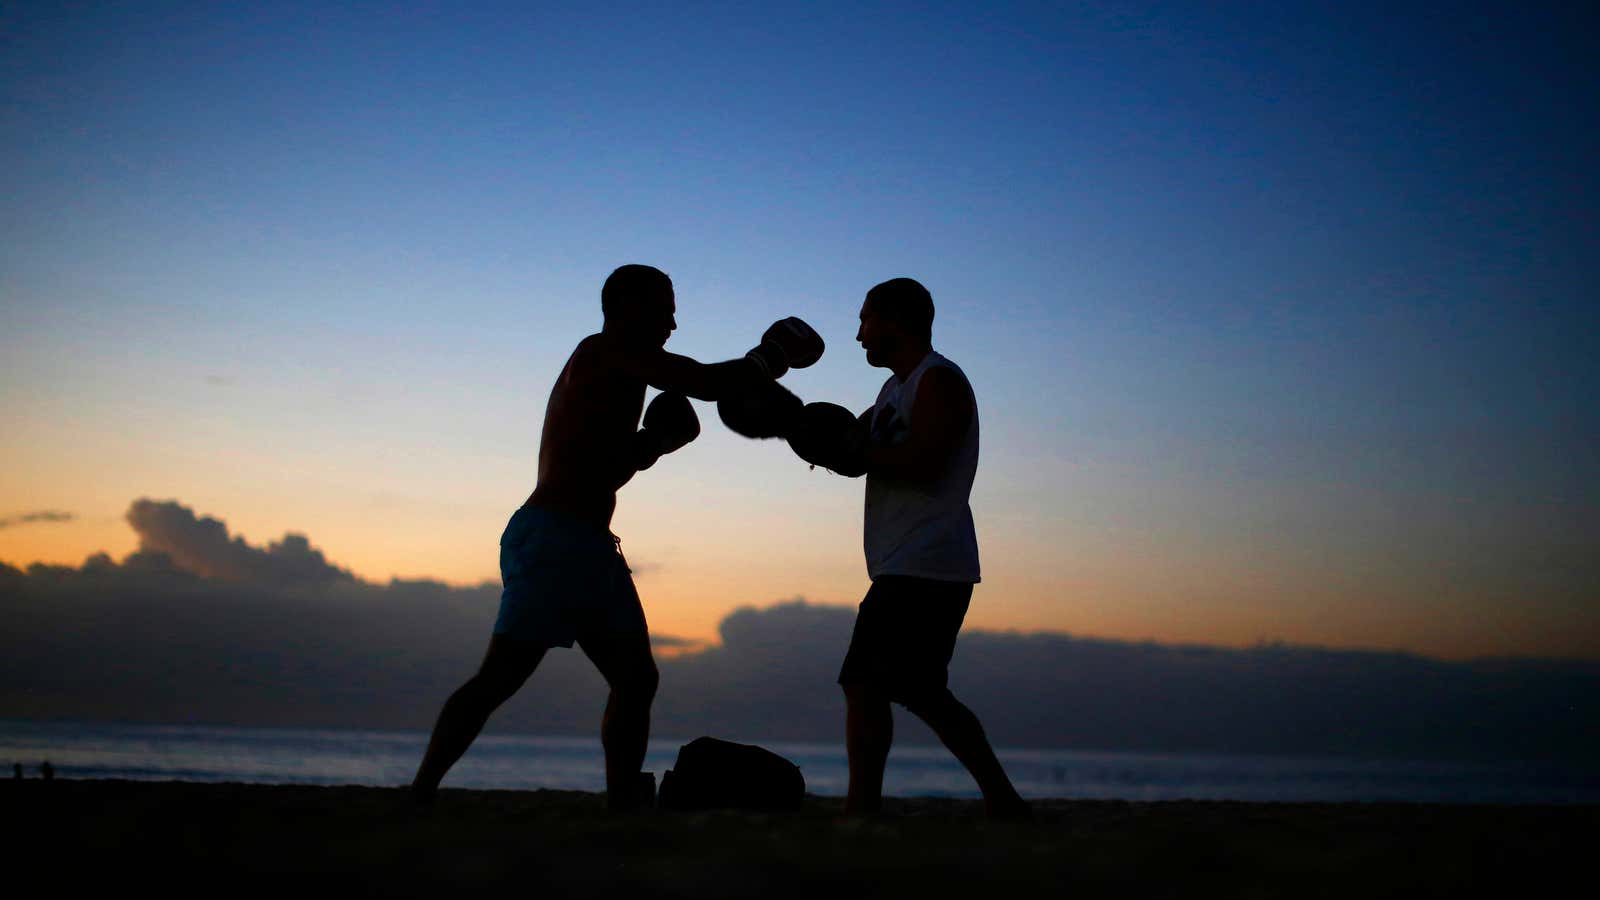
[411, 634, 546, 802]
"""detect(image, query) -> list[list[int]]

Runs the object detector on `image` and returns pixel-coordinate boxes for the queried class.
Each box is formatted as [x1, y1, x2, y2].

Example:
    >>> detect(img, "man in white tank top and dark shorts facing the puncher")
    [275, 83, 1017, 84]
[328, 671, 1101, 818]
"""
[838, 279, 1029, 817]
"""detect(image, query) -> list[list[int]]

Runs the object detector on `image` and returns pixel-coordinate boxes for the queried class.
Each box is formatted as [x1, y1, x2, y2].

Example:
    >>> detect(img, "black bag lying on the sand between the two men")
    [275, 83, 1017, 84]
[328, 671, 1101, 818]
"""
[656, 738, 805, 810]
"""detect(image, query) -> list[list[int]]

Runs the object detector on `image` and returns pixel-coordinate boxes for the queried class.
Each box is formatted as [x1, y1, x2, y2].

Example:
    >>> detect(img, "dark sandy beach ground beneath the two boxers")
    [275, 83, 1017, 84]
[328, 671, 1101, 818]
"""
[0, 780, 1600, 900]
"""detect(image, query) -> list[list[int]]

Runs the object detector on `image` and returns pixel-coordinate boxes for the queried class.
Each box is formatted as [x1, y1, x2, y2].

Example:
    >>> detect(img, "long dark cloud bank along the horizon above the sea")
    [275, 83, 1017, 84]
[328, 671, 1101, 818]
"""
[0, 501, 1600, 761]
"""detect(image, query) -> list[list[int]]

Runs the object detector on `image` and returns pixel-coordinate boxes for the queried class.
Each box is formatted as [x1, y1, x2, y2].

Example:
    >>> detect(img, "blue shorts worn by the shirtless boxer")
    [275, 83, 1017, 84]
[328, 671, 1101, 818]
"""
[494, 506, 648, 647]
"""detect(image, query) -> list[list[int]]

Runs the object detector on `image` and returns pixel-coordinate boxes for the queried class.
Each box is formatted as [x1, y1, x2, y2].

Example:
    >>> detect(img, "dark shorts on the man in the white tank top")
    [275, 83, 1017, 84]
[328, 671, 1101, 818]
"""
[838, 575, 973, 703]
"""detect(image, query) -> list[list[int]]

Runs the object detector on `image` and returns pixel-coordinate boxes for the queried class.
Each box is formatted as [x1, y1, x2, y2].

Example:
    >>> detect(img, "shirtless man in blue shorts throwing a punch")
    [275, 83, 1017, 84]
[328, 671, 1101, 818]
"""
[411, 266, 822, 810]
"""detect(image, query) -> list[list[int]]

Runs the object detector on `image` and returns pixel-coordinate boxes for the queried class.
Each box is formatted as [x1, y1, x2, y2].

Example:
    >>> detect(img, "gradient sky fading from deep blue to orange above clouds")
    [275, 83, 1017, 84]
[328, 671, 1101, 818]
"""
[0, 3, 1600, 658]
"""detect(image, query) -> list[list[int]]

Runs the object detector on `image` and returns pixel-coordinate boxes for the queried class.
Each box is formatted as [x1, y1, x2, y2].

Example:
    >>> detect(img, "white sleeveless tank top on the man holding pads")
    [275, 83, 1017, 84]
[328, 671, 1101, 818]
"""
[864, 351, 981, 583]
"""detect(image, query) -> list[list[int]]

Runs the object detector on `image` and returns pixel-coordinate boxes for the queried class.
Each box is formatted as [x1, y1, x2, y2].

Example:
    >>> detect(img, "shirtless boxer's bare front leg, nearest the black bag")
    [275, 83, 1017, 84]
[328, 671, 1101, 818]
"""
[579, 631, 661, 810]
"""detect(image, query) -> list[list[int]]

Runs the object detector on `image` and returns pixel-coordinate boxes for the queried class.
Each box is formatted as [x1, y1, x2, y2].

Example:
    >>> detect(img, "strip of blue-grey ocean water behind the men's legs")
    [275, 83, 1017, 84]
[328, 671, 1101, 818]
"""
[0, 721, 1600, 804]
